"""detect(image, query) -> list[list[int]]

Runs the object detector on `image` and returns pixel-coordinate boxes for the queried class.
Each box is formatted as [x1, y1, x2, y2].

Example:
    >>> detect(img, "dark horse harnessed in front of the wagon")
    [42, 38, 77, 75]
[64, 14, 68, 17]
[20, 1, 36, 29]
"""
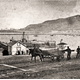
[29, 49, 43, 62]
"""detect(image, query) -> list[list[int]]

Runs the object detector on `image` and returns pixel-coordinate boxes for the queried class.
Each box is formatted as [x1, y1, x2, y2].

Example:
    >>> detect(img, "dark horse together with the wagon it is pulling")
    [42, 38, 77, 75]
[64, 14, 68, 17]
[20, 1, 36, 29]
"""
[30, 43, 68, 61]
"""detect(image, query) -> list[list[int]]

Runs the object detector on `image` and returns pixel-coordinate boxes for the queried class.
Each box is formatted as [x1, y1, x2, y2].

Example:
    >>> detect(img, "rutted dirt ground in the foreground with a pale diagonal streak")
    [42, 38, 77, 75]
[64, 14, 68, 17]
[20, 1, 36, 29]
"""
[0, 55, 80, 79]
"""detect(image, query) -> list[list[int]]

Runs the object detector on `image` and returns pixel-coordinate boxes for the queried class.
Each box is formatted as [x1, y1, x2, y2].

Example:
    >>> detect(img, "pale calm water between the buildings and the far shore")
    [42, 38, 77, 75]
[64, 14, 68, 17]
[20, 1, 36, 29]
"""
[0, 35, 80, 50]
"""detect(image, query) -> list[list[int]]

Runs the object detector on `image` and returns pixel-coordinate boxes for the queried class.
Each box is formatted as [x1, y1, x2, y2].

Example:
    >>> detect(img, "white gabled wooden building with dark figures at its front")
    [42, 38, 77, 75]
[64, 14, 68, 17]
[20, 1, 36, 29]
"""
[8, 41, 29, 55]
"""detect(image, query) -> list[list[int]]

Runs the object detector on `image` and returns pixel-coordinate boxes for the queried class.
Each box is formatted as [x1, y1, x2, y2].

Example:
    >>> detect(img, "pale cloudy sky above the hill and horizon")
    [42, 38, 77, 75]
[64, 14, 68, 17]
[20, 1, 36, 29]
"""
[0, 0, 80, 29]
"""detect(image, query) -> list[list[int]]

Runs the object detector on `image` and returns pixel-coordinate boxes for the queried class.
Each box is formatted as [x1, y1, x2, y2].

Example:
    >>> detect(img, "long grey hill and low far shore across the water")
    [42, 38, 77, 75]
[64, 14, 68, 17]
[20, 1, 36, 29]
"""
[0, 15, 80, 35]
